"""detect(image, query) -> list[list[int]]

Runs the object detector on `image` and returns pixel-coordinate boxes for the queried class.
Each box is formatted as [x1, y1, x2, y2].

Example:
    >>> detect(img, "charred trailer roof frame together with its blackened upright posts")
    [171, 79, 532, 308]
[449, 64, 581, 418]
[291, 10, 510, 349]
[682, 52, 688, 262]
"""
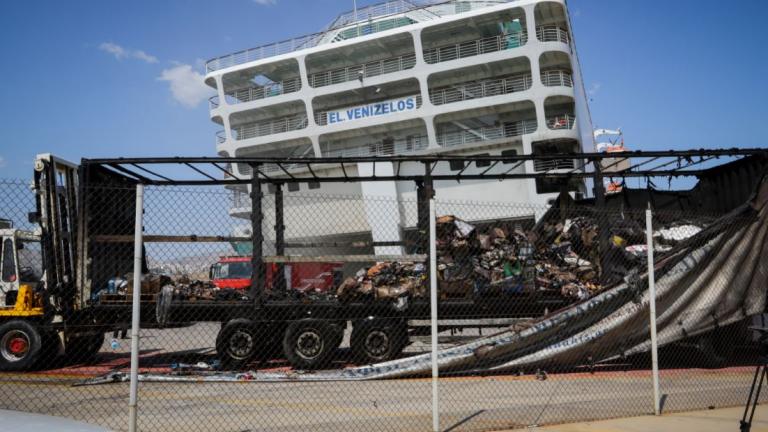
[81, 148, 768, 305]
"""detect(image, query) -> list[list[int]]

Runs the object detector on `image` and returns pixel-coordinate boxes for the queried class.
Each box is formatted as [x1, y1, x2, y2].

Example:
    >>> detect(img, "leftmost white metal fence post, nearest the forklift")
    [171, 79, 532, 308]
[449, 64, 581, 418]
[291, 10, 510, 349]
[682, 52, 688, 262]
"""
[128, 183, 144, 432]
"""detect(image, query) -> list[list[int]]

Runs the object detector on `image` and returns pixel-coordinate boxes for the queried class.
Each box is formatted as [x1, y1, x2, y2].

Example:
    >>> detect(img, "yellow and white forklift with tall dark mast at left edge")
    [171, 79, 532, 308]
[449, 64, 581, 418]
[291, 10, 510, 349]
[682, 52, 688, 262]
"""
[0, 154, 110, 371]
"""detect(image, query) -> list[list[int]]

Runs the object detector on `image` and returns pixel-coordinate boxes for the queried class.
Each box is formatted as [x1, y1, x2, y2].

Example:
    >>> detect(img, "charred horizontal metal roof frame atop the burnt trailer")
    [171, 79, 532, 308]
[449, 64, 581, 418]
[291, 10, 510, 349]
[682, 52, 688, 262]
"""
[82, 148, 768, 186]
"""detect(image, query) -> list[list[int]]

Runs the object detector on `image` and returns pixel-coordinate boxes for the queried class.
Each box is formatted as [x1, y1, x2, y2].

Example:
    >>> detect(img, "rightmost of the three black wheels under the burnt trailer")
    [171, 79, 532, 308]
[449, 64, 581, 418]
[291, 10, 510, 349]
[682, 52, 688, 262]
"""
[351, 318, 408, 364]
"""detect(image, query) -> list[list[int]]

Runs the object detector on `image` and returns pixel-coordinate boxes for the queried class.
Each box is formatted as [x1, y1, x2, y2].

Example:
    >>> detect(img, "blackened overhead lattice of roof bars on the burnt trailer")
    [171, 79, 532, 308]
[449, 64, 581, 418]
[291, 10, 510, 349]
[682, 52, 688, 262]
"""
[81, 148, 768, 185]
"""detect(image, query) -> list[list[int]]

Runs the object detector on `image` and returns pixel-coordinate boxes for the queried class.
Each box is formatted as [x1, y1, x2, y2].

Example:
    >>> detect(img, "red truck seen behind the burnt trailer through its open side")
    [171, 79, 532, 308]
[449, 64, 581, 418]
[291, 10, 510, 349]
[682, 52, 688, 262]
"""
[210, 256, 342, 291]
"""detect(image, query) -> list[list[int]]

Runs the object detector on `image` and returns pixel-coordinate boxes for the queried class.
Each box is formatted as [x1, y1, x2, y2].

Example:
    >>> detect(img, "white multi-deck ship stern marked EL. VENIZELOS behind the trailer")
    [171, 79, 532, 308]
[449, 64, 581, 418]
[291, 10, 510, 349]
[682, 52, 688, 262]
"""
[206, 0, 592, 248]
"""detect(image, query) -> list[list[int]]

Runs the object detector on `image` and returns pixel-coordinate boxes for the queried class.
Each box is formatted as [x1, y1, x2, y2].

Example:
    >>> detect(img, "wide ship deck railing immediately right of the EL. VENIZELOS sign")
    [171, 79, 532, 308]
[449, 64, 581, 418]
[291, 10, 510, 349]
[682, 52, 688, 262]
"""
[429, 73, 532, 105]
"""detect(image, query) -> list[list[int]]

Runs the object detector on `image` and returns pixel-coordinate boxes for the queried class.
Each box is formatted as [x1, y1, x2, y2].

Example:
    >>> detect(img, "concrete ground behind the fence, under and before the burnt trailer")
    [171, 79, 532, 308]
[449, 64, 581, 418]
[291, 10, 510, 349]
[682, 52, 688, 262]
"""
[0, 324, 768, 432]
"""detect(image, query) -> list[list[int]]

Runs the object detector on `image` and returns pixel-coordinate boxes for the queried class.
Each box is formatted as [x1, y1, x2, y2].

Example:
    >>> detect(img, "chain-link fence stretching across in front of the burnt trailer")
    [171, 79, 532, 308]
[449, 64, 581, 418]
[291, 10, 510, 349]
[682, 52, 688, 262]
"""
[0, 177, 768, 432]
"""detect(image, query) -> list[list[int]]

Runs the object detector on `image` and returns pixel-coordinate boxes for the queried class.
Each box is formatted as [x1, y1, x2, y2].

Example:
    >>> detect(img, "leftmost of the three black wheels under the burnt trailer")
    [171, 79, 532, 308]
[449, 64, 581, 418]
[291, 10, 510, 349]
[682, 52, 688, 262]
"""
[216, 318, 263, 369]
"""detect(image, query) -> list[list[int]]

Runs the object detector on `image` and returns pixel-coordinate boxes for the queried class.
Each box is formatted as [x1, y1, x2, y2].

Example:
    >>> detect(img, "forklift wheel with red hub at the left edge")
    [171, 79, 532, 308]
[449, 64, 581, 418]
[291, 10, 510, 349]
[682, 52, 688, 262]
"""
[0, 320, 43, 371]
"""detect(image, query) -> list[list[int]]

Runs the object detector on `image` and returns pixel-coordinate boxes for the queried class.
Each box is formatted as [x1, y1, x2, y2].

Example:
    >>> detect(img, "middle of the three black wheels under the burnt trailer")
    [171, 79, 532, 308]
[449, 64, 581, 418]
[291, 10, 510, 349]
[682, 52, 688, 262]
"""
[283, 319, 340, 369]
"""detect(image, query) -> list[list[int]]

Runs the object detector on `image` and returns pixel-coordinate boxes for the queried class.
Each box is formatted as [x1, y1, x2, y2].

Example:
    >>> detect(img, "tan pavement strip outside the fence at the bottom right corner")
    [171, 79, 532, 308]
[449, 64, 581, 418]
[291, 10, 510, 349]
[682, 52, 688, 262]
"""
[504, 405, 768, 432]
